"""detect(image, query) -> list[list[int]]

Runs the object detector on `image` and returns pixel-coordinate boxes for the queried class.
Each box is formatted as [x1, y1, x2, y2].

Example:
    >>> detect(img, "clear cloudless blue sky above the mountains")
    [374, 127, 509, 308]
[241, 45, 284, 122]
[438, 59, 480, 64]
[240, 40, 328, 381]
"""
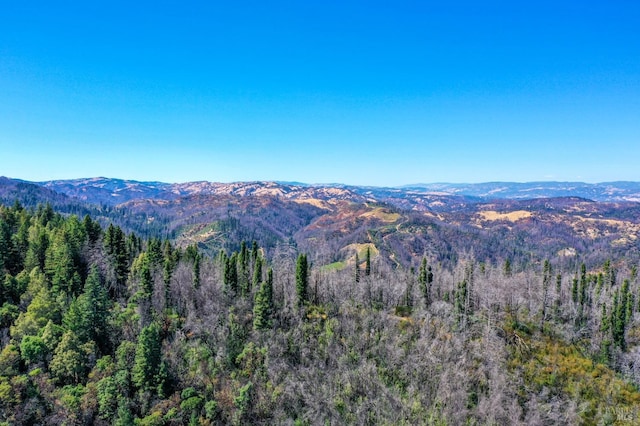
[0, 0, 640, 185]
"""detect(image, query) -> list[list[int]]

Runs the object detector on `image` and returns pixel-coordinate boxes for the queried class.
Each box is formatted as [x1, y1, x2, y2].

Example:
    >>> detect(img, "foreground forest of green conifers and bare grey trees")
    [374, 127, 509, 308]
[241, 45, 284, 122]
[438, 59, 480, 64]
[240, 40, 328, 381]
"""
[0, 203, 640, 425]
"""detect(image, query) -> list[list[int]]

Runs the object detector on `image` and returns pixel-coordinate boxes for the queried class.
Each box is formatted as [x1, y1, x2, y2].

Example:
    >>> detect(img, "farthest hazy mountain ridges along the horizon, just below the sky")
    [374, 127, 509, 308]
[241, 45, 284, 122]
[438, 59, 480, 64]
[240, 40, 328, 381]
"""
[17, 178, 640, 205]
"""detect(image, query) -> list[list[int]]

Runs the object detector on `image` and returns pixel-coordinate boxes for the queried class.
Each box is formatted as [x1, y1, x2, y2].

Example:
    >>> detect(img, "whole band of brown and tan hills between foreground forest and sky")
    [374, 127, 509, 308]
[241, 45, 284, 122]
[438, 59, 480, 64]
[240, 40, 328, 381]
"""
[0, 178, 640, 265]
